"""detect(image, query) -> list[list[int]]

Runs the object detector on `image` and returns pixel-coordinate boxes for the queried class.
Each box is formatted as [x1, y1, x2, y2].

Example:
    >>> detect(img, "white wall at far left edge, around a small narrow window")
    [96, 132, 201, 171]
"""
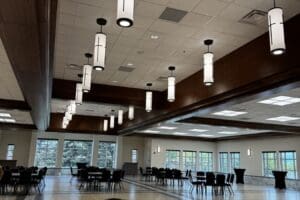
[0, 130, 31, 166]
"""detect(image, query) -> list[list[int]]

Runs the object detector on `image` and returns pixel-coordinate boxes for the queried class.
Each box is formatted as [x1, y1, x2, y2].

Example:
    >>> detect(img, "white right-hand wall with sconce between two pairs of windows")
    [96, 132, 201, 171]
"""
[217, 136, 300, 176]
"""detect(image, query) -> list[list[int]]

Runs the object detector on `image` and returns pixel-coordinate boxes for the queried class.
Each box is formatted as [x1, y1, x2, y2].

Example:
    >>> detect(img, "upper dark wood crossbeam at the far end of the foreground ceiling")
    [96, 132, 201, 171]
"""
[52, 79, 162, 109]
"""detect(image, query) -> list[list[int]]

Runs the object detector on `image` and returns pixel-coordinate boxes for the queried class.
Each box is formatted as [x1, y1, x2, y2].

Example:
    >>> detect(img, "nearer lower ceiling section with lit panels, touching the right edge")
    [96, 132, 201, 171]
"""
[195, 87, 300, 127]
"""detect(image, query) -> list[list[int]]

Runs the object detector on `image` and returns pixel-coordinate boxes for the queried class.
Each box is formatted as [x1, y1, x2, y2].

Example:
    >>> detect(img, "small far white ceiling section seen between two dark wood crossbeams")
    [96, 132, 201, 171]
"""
[51, 99, 128, 117]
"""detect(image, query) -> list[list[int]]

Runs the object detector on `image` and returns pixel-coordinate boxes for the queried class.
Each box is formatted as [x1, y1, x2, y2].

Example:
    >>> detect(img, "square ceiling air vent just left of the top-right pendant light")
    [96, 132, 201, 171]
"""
[239, 10, 267, 25]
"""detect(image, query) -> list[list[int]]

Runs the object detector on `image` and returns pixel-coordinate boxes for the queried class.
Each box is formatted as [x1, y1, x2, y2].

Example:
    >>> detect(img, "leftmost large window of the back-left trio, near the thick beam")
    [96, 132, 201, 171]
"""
[34, 139, 58, 167]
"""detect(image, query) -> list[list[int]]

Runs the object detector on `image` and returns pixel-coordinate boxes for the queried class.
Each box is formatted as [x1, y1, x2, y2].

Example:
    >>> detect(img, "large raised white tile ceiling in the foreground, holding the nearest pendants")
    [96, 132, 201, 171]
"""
[54, 0, 300, 90]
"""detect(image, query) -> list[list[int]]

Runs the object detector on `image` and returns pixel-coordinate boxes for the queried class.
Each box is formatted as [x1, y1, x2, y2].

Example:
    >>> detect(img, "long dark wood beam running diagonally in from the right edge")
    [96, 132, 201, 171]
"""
[119, 15, 300, 134]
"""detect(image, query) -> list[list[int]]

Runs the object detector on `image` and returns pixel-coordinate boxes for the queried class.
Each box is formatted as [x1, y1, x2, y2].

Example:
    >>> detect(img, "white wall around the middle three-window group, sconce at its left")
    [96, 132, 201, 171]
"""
[151, 139, 217, 169]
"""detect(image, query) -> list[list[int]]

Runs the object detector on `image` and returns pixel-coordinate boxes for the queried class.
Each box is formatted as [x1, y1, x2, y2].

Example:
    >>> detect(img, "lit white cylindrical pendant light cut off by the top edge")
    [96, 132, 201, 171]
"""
[117, 0, 134, 28]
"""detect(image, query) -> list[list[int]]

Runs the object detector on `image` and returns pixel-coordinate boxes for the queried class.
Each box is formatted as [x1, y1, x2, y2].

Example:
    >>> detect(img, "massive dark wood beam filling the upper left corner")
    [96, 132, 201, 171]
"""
[0, 0, 57, 130]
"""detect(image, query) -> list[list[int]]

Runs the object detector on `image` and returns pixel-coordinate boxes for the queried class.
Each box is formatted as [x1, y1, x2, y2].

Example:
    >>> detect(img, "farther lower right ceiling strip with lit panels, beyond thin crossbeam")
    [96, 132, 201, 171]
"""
[136, 123, 269, 138]
